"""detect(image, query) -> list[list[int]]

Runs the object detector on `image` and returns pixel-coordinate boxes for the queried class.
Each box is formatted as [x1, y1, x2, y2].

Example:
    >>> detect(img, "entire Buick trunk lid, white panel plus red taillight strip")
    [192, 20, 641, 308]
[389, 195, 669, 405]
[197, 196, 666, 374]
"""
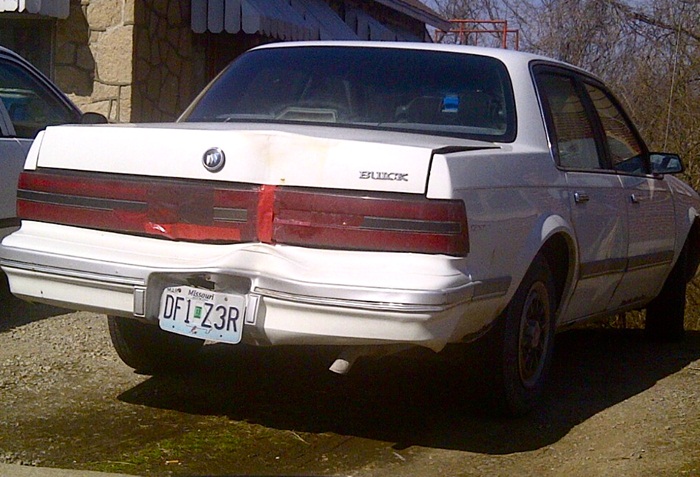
[17, 124, 493, 256]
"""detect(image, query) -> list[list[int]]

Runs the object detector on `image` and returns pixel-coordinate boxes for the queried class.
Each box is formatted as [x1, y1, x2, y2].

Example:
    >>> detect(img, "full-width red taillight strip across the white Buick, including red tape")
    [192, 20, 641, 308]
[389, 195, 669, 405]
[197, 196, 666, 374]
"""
[17, 171, 469, 255]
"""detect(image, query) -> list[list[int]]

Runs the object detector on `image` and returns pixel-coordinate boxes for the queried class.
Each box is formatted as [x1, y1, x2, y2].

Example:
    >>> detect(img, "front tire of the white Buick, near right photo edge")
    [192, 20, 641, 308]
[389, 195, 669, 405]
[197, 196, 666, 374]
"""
[644, 247, 688, 342]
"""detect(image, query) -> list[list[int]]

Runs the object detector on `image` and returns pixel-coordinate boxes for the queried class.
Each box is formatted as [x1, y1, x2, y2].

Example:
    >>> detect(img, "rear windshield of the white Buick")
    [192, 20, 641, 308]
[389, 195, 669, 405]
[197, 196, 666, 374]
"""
[180, 46, 516, 142]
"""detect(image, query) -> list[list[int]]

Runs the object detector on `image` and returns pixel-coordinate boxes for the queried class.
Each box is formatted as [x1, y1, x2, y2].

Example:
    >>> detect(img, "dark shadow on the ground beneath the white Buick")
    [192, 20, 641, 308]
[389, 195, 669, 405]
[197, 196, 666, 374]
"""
[119, 329, 700, 455]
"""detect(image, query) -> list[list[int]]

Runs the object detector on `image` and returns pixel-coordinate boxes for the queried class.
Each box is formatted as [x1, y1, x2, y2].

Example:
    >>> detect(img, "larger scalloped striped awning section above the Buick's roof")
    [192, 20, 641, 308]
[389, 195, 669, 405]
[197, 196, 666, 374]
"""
[191, 0, 357, 40]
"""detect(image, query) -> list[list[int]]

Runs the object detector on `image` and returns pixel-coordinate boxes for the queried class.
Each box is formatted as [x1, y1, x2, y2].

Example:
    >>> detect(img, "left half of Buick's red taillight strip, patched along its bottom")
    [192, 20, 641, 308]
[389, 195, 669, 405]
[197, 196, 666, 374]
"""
[17, 171, 259, 243]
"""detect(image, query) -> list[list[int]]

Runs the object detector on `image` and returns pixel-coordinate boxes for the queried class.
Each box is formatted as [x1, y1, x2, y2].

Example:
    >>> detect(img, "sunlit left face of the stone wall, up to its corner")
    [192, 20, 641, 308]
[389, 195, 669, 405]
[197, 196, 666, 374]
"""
[55, 0, 135, 122]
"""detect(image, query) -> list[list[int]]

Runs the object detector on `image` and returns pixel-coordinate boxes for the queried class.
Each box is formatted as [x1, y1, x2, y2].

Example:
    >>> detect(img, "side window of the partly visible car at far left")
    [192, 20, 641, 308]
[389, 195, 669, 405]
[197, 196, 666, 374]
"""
[0, 61, 78, 139]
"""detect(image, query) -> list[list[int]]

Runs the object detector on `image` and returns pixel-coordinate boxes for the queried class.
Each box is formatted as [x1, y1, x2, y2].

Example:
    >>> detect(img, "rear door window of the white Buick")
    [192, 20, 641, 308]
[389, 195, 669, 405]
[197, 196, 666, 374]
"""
[537, 73, 603, 170]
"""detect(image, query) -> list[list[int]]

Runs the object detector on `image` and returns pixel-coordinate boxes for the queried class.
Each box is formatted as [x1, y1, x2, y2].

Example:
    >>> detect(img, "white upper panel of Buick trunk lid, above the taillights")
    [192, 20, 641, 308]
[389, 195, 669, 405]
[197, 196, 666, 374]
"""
[34, 125, 432, 194]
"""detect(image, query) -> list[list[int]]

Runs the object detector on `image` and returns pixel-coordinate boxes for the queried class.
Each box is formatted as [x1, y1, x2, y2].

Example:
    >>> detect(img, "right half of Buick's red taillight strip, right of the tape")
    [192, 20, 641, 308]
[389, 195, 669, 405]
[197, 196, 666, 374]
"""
[274, 189, 469, 255]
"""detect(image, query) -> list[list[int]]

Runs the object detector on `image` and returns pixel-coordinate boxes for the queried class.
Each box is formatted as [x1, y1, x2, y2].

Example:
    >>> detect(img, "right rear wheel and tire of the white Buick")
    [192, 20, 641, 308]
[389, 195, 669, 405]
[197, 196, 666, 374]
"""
[489, 255, 557, 417]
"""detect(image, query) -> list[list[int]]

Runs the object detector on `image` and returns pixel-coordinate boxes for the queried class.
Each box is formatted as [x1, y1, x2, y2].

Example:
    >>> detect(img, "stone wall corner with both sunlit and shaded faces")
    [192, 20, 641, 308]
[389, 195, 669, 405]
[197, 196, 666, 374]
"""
[54, 0, 208, 122]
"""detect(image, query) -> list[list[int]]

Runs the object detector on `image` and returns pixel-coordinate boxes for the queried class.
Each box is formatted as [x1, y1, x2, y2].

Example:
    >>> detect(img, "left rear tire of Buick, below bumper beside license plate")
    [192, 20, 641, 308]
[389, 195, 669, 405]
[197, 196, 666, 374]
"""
[108, 316, 204, 374]
